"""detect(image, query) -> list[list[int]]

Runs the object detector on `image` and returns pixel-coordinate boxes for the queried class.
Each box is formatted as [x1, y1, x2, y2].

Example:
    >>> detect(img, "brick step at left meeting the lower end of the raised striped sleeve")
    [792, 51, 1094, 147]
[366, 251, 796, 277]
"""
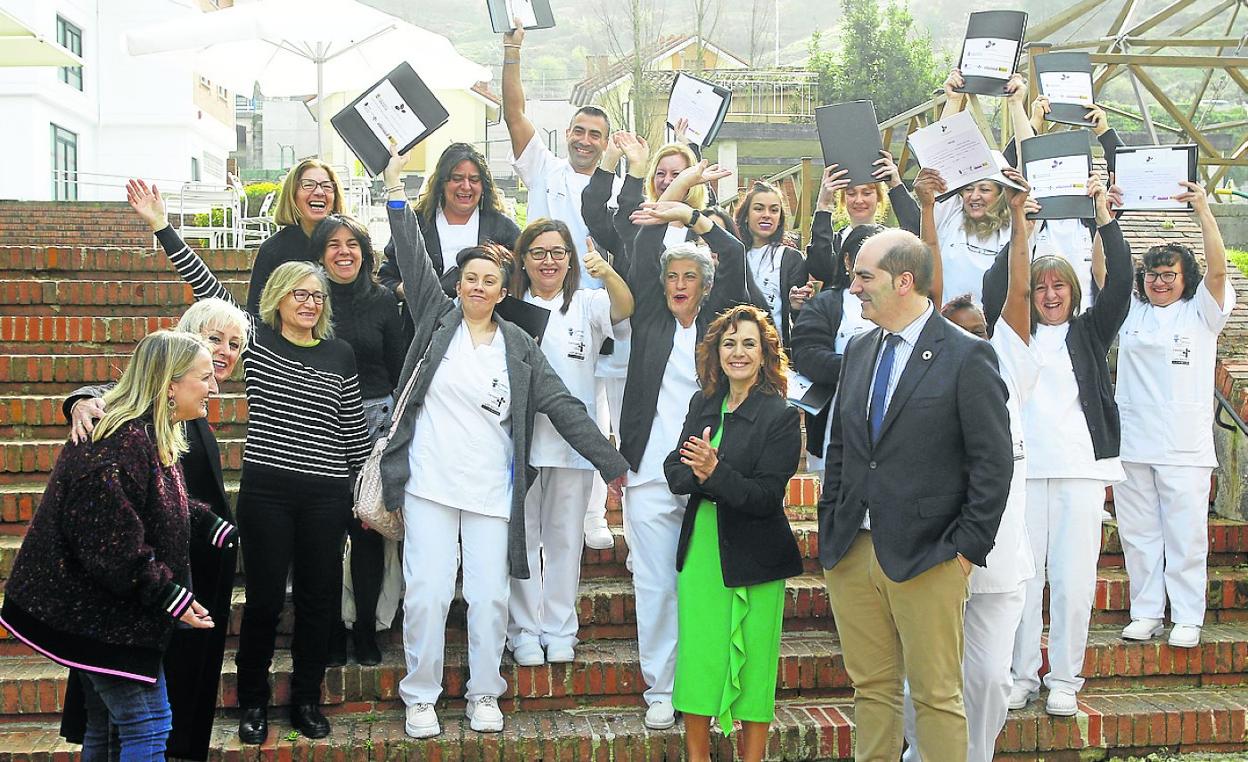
[0, 279, 247, 311]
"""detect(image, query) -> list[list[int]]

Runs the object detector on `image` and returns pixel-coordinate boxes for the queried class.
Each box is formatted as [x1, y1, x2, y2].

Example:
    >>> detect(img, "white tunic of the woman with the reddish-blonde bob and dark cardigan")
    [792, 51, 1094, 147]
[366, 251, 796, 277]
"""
[1022, 323, 1126, 484]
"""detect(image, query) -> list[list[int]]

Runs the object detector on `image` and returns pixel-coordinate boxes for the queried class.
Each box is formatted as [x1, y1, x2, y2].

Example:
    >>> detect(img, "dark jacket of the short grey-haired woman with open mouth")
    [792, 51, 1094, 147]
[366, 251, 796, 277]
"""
[620, 224, 749, 470]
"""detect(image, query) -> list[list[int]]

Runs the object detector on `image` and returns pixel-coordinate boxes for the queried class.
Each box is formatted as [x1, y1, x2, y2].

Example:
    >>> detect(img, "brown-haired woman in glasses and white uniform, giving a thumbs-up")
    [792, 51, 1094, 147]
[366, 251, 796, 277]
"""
[507, 219, 633, 666]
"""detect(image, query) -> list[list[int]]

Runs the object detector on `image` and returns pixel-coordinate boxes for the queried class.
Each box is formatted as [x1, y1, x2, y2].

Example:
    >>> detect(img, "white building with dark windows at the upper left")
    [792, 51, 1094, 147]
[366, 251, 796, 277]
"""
[0, 0, 235, 201]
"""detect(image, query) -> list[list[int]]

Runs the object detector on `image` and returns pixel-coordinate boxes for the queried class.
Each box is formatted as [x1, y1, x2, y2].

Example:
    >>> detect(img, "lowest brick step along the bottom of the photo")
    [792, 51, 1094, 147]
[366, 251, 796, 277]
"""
[7, 688, 1248, 762]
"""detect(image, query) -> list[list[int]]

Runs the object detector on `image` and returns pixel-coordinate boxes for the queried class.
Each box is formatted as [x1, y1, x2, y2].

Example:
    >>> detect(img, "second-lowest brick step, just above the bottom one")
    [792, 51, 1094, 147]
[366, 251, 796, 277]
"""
[7, 625, 1248, 716]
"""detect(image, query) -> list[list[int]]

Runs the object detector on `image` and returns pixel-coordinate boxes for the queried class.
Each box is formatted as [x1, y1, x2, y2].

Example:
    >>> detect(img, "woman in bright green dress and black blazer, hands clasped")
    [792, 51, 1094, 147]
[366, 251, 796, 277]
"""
[664, 304, 802, 762]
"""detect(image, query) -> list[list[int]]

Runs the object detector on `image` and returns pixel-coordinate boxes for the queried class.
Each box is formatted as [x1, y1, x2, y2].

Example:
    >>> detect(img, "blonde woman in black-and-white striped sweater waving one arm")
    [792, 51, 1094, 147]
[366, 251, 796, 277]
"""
[126, 181, 368, 743]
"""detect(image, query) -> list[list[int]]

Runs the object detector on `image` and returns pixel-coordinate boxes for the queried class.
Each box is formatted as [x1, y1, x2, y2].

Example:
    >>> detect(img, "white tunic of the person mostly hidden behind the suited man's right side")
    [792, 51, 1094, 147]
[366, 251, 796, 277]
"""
[971, 319, 1040, 594]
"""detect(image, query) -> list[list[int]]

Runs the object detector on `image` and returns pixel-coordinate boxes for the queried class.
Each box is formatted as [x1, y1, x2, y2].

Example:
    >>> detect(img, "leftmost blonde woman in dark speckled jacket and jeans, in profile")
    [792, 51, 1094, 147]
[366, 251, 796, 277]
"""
[0, 330, 235, 760]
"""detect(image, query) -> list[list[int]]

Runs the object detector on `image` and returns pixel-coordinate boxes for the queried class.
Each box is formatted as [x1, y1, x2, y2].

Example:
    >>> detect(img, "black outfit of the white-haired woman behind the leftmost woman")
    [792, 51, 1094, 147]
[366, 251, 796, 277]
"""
[61, 391, 238, 761]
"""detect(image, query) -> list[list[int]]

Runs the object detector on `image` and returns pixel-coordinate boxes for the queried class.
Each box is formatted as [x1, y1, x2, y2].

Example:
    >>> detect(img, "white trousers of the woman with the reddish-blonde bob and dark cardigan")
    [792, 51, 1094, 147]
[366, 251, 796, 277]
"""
[1012, 479, 1104, 692]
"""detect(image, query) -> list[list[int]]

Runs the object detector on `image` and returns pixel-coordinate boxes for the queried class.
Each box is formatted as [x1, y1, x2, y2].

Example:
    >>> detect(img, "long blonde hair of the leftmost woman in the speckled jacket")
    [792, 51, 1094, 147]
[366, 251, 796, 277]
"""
[91, 330, 212, 465]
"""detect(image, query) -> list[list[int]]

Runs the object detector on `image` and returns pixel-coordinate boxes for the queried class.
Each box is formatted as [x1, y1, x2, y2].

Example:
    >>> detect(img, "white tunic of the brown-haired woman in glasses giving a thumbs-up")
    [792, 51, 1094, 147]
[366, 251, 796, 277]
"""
[524, 288, 612, 470]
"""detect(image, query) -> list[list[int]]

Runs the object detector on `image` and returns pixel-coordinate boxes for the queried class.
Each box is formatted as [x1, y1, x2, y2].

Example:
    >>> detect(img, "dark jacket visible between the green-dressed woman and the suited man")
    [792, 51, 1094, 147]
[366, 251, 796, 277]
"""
[789, 287, 857, 458]
